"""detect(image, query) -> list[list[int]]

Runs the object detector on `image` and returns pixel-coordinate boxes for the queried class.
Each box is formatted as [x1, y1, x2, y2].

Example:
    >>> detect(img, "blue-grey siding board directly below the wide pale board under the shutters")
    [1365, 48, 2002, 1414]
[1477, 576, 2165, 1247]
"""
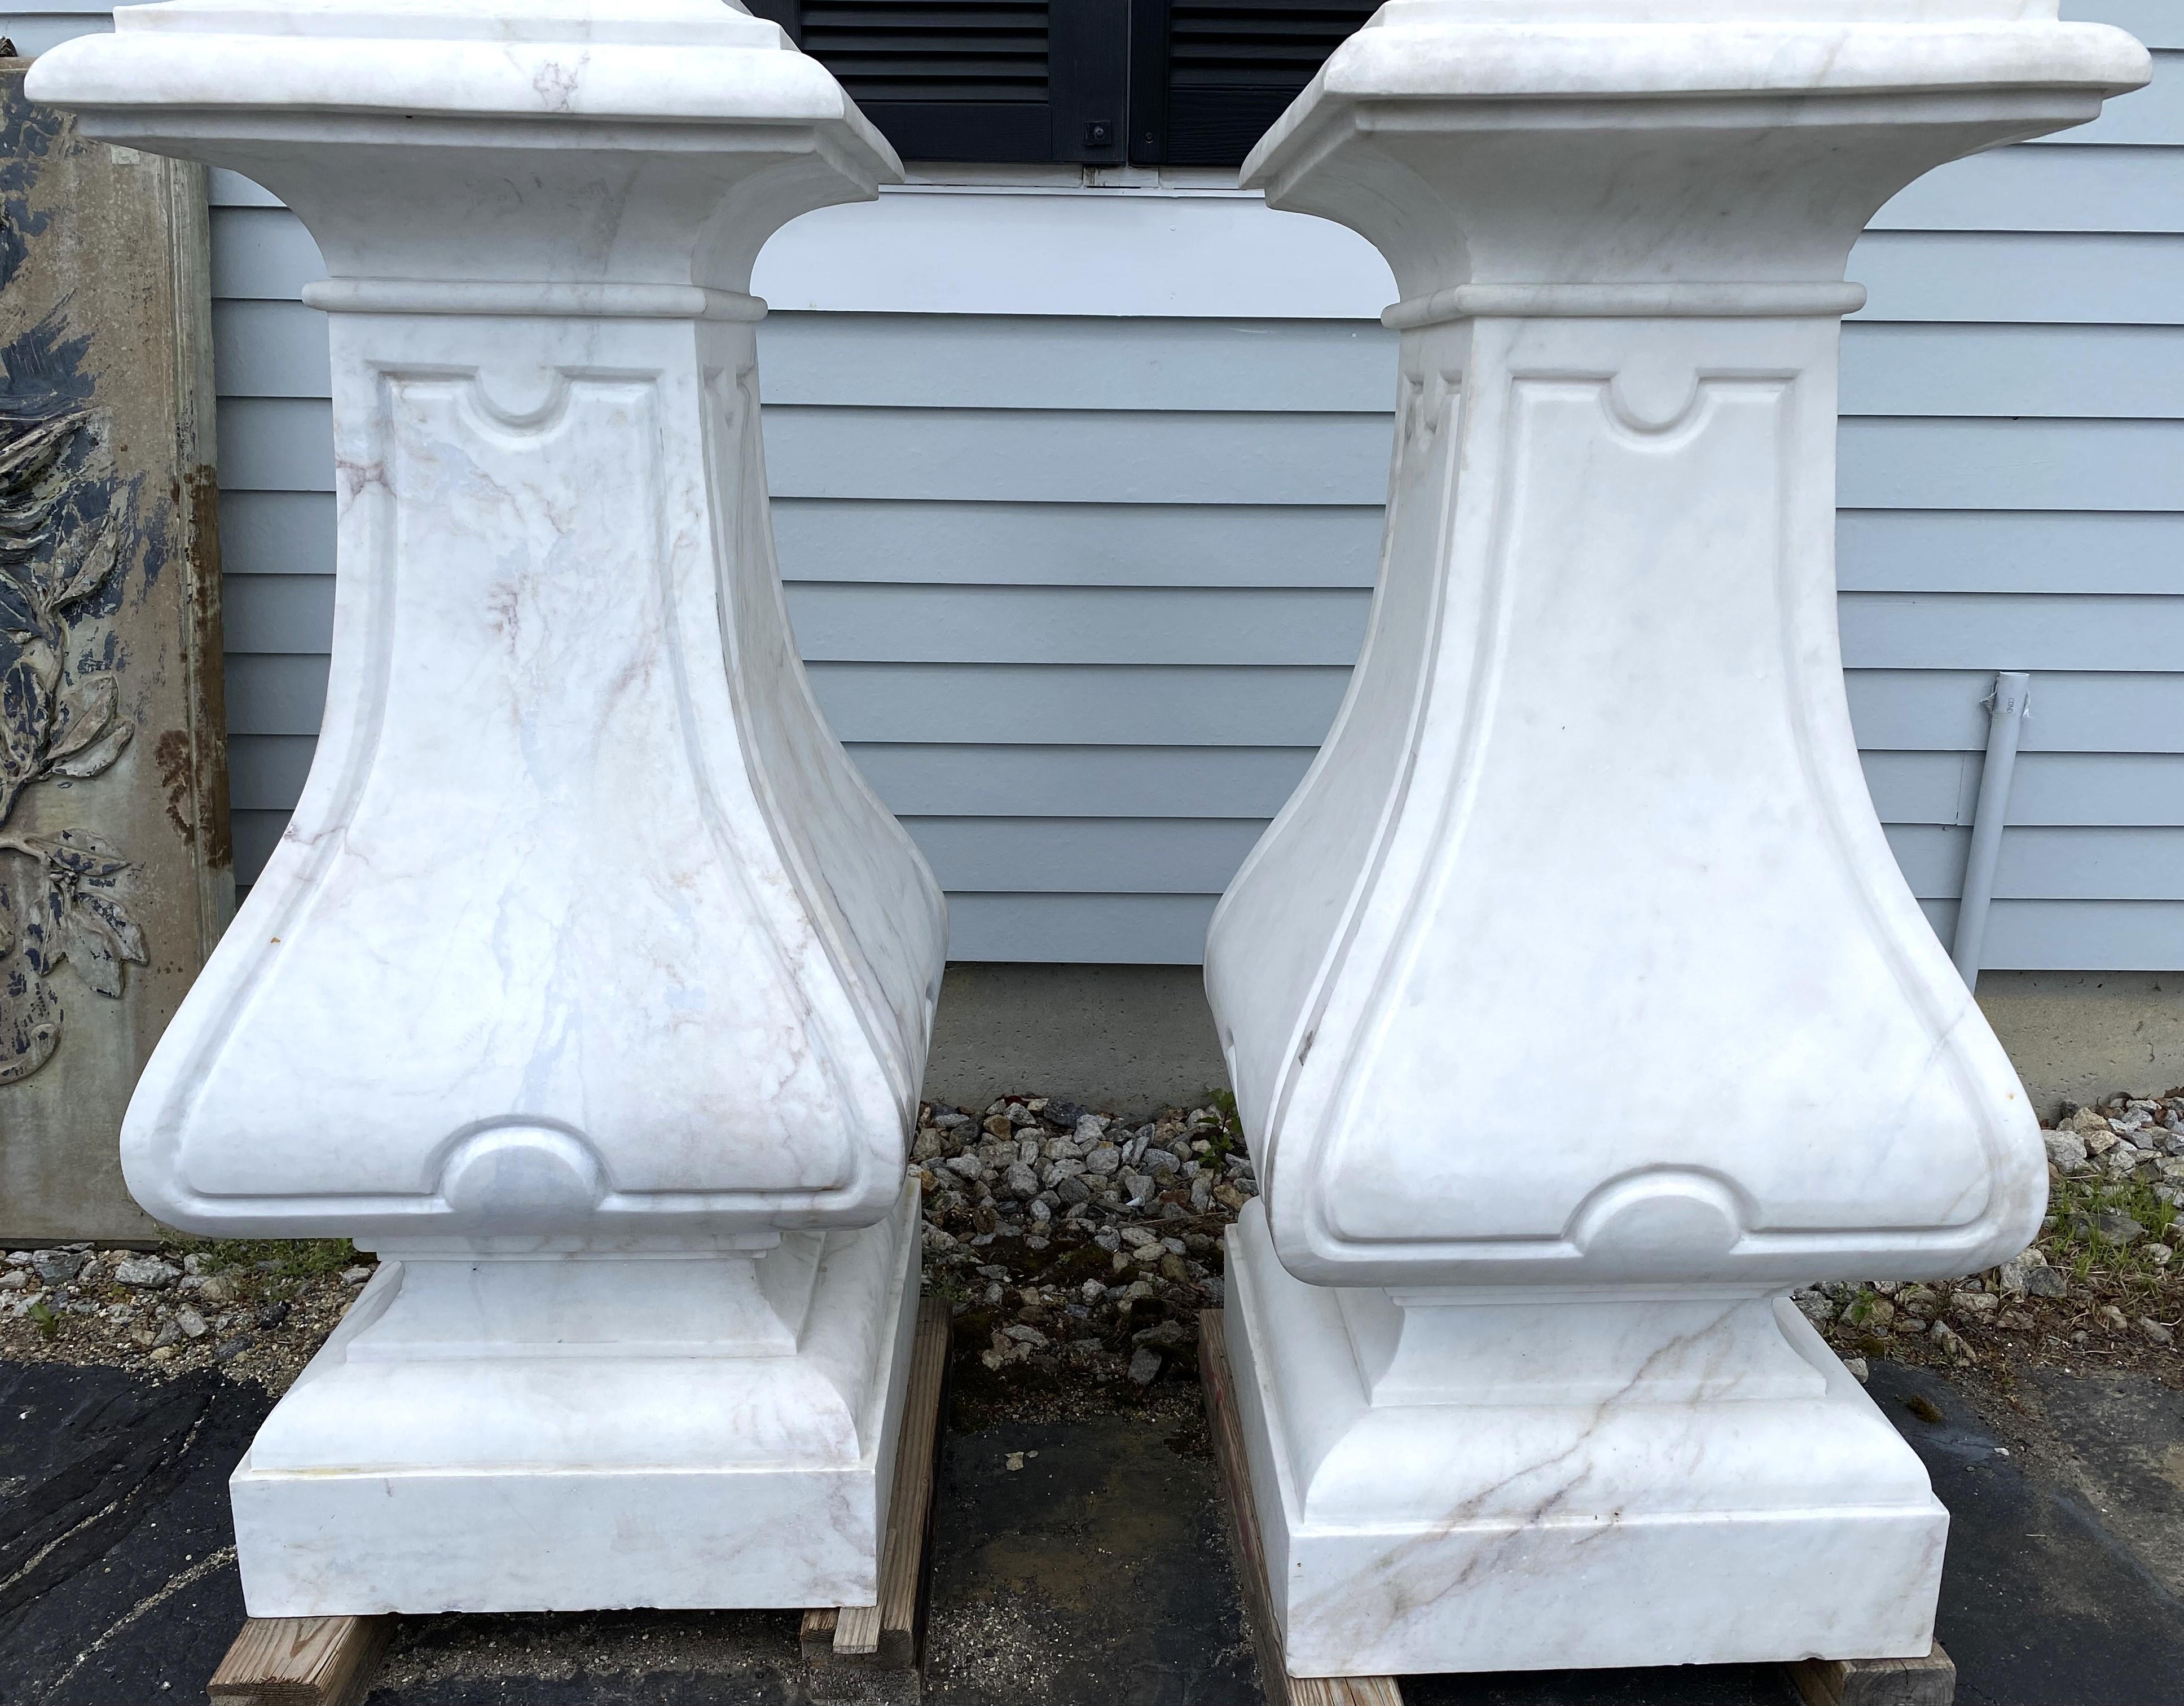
[212, 301, 2184, 419]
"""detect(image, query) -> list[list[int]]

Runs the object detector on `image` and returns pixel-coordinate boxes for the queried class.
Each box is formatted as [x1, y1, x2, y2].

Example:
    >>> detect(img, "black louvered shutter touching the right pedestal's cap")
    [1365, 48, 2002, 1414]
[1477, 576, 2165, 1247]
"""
[1129, 0, 1374, 166]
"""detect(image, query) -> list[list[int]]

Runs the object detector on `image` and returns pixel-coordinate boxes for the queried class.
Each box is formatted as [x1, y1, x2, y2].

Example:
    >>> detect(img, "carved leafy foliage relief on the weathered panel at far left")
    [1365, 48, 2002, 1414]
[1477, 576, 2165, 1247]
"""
[0, 408, 146, 1083]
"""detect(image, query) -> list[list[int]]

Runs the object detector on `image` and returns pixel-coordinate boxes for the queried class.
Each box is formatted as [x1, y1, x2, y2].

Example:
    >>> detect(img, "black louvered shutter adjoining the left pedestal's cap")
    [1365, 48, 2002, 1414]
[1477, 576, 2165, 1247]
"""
[747, 0, 1129, 164]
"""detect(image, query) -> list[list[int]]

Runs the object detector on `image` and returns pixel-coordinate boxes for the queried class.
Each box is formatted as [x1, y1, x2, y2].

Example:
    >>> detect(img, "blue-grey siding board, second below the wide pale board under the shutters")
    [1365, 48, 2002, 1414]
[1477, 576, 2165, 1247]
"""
[221, 398, 2184, 511]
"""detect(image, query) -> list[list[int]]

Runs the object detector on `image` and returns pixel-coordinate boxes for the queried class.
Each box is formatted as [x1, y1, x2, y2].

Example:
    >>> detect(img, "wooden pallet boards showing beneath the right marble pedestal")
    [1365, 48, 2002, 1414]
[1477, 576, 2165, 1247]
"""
[1199, 1308, 1957, 1706]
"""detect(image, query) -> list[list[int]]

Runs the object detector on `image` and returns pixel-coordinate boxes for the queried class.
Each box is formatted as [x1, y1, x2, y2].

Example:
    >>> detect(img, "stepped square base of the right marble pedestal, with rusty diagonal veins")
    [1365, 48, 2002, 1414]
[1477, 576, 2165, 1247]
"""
[1228, 1202, 1948, 1676]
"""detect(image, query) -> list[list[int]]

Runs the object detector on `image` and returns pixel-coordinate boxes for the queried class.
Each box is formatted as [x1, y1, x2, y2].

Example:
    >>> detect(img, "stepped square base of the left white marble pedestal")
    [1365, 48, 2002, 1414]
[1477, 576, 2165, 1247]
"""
[229, 1184, 917, 1616]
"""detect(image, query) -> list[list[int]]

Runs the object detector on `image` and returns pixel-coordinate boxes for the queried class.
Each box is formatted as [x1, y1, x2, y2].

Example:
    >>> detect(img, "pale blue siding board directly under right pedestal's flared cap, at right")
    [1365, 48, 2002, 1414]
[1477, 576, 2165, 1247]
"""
[1870, 146, 2184, 231]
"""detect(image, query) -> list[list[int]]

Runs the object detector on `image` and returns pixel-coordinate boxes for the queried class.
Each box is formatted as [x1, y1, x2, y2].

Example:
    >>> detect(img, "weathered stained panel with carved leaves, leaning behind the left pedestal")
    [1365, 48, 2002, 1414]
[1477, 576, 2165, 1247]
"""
[0, 61, 234, 1241]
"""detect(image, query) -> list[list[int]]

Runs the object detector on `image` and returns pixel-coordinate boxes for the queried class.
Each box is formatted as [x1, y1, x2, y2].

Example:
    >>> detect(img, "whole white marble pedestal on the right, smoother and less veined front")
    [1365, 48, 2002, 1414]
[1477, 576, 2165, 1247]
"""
[1208, 0, 2147, 1676]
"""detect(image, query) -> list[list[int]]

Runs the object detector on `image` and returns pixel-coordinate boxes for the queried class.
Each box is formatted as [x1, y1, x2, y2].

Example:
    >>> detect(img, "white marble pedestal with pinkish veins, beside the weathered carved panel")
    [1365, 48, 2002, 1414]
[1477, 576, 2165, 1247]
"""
[30, 0, 943, 1616]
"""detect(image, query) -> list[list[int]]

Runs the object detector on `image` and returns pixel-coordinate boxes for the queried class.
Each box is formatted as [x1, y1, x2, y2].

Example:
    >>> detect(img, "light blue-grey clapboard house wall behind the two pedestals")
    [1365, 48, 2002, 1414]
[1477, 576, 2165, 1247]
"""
[12, 0, 2184, 972]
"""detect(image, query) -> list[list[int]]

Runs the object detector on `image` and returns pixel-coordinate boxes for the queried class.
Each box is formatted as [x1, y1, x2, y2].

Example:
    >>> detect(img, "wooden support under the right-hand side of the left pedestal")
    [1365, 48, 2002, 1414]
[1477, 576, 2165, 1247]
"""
[799, 1298, 952, 1671]
